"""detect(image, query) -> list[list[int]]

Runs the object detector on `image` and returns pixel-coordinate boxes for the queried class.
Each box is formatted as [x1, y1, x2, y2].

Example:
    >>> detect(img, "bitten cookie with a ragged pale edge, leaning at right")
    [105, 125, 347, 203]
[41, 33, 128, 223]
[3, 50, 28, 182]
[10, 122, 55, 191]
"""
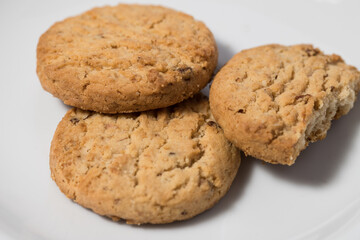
[210, 45, 360, 165]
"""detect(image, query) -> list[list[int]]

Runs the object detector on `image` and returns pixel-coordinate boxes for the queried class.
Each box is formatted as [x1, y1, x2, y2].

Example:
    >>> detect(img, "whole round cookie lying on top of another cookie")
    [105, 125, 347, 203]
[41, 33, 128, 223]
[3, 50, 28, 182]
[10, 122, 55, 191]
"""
[37, 4, 218, 113]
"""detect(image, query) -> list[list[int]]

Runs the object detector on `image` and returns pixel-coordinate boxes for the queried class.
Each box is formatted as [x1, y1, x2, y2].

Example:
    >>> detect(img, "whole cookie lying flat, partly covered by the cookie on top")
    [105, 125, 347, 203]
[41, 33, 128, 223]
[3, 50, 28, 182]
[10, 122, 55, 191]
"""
[50, 95, 240, 224]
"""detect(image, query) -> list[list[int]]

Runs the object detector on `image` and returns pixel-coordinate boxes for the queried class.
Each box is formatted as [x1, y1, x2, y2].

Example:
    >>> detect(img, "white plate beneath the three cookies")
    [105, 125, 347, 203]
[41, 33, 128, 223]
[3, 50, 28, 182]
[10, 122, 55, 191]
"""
[0, 0, 360, 240]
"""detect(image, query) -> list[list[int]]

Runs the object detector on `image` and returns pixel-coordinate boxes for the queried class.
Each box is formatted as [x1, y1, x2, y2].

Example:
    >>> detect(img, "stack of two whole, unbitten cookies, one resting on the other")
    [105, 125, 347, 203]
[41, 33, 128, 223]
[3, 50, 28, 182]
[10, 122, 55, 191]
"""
[37, 4, 240, 224]
